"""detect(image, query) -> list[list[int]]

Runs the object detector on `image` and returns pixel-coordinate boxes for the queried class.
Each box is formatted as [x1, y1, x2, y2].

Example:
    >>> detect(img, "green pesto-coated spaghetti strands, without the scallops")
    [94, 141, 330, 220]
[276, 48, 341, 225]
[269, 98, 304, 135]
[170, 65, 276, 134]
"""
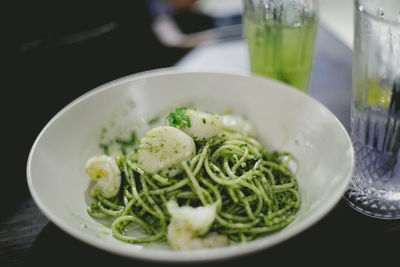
[88, 125, 301, 247]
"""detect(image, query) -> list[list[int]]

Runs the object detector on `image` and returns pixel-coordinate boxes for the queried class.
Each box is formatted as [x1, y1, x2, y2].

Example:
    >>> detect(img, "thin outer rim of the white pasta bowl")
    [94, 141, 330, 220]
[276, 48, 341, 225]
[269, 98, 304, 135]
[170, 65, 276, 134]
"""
[26, 67, 355, 263]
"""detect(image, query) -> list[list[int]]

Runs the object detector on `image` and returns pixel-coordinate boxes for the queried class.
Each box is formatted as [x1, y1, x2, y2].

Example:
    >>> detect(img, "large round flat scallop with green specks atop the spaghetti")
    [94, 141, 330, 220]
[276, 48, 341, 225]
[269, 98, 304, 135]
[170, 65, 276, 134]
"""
[138, 126, 196, 176]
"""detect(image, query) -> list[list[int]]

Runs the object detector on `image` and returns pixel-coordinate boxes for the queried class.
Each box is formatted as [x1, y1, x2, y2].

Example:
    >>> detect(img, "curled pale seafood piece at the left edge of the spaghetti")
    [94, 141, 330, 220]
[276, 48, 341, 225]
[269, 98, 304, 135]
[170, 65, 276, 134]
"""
[85, 155, 121, 198]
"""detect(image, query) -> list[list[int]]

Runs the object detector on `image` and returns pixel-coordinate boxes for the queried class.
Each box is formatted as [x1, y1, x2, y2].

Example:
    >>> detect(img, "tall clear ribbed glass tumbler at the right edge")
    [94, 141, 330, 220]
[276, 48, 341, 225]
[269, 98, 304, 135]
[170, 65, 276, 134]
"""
[345, 0, 400, 219]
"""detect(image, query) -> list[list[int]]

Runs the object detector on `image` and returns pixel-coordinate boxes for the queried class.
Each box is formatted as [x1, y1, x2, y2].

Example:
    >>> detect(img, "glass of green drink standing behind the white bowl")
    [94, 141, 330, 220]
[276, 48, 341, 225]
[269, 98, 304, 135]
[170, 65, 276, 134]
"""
[243, 0, 318, 92]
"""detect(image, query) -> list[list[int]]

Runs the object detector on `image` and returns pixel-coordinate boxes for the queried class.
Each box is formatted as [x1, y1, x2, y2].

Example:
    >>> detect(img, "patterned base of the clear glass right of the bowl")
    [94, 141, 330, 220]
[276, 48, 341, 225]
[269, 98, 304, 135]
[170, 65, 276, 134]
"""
[344, 185, 400, 220]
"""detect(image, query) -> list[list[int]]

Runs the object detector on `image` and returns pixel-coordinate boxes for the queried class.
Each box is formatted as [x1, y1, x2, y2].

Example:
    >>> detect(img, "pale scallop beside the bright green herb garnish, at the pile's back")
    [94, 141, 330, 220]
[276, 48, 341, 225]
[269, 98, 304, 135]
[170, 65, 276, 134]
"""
[182, 109, 222, 141]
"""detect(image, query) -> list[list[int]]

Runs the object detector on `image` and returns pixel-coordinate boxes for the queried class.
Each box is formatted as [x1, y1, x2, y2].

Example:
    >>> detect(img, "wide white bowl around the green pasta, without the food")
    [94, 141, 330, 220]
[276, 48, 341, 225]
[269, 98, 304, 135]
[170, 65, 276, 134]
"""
[27, 69, 354, 262]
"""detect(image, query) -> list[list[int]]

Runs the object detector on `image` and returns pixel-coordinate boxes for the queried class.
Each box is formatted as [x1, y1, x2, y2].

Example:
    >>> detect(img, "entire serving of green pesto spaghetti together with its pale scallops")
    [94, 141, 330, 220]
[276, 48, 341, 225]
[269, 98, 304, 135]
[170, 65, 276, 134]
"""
[86, 108, 301, 250]
